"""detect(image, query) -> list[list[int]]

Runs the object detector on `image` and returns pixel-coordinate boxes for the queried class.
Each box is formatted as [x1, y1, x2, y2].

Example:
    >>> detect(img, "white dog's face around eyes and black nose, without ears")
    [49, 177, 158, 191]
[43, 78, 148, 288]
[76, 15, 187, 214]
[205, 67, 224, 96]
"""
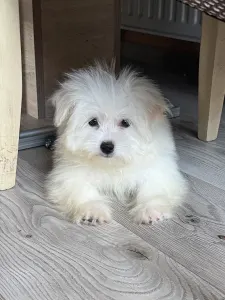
[65, 93, 150, 161]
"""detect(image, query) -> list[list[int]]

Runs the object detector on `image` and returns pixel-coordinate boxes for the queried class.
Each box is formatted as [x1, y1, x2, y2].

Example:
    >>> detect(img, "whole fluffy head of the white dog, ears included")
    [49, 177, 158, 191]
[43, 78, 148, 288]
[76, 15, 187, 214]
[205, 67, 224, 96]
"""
[53, 66, 165, 162]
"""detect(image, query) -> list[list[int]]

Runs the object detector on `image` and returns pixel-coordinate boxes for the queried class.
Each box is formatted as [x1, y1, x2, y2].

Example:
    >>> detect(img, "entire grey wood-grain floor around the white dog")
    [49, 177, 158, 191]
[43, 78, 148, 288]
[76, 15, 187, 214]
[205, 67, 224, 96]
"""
[0, 87, 225, 300]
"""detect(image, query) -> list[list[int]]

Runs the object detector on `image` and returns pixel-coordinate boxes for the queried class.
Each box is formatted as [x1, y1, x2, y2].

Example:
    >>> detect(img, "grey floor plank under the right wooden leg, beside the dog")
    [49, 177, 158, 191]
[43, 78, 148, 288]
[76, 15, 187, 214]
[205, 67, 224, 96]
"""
[173, 117, 225, 189]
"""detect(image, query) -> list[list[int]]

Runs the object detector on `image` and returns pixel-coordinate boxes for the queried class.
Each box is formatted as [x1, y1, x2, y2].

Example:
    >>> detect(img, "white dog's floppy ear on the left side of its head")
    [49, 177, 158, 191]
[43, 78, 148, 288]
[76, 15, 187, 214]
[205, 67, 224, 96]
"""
[49, 88, 75, 127]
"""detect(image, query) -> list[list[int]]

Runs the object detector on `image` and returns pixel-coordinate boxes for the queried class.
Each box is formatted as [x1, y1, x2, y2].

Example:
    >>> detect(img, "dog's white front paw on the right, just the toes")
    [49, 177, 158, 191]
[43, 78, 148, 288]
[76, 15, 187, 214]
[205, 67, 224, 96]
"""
[130, 204, 172, 224]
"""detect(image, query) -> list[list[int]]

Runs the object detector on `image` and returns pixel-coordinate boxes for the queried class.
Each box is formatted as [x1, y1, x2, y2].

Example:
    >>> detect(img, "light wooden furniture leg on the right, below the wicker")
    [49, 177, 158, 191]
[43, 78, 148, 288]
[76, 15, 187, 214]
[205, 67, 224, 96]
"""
[198, 14, 225, 141]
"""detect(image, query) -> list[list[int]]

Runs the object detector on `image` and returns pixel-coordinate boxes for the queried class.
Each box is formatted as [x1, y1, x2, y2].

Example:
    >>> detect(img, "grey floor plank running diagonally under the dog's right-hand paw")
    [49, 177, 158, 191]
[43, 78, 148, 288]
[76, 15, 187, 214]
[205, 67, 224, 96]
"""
[112, 171, 225, 292]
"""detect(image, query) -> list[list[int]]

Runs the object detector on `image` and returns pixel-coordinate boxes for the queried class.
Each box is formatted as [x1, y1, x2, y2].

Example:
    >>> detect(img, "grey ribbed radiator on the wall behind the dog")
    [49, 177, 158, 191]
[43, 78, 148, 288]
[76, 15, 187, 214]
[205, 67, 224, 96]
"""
[121, 0, 201, 41]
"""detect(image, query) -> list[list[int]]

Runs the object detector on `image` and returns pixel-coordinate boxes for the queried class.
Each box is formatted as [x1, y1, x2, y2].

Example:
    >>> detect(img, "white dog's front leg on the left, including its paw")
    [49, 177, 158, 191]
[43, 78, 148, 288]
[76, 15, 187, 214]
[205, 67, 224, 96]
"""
[47, 176, 111, 225]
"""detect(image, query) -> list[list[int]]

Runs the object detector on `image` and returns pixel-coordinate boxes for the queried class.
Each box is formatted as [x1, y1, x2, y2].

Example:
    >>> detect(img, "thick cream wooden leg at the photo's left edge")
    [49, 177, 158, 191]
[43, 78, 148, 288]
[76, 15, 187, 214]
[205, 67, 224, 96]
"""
[0, 0, 22, 190]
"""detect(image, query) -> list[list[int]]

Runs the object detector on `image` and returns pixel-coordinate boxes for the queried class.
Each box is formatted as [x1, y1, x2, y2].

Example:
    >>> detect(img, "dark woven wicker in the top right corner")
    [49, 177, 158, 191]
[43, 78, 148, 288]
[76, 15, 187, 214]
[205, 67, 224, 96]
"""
[181, 0, 225, 21]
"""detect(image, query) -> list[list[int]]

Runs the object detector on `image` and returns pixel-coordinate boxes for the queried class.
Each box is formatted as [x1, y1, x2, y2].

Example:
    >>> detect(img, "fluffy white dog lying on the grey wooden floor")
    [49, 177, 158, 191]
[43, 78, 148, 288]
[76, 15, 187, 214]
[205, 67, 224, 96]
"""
[46, 64, 186, 224]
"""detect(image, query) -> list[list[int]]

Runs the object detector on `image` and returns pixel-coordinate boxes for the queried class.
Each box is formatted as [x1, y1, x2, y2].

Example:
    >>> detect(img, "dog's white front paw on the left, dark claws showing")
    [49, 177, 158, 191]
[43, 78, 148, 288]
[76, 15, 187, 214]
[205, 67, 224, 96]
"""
[74, 202, 111, 225]
